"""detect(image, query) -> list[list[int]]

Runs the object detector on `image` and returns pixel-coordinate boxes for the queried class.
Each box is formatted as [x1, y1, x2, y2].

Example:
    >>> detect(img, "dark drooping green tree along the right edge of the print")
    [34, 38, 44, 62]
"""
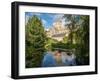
[75, 15, 89, 65]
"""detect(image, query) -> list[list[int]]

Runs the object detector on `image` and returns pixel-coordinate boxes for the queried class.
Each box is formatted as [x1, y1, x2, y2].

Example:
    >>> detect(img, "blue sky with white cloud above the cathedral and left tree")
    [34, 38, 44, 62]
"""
[25, 12, 64, 29]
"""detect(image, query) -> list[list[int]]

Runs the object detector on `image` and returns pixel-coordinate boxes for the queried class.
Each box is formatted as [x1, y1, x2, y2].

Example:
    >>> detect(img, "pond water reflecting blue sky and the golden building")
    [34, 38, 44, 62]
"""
[42, 52, 76, 67]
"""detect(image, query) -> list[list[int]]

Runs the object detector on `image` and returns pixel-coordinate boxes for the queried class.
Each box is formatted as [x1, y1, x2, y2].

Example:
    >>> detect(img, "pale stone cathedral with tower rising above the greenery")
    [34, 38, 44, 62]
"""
[46, 21, 68, 41]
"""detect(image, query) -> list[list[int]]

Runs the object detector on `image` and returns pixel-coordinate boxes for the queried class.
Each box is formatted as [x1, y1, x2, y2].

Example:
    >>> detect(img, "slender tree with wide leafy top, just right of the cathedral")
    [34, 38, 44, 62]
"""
[64, 14, 80, 44]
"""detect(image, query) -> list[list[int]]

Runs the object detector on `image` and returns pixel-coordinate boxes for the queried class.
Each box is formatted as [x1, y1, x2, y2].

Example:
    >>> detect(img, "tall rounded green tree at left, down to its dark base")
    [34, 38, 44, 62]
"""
[25, 16, 46, 68]
